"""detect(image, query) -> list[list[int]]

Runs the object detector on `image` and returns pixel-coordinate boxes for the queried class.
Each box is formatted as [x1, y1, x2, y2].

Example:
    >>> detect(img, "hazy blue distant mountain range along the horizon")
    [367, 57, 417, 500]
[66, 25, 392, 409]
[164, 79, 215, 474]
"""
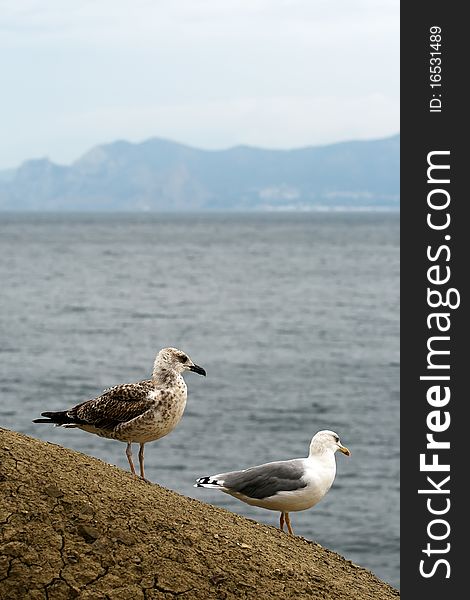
[0, 135, 400, 212]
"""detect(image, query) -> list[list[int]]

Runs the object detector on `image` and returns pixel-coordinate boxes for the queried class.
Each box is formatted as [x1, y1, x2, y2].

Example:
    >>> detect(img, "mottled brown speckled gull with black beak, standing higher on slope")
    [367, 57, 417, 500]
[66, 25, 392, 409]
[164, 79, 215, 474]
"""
[33, 348, 206, 479]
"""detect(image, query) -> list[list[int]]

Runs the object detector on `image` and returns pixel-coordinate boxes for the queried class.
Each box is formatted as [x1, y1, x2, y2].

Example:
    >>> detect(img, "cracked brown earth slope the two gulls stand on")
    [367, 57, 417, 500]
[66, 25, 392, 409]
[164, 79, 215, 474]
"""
[0, 428, 399, 600]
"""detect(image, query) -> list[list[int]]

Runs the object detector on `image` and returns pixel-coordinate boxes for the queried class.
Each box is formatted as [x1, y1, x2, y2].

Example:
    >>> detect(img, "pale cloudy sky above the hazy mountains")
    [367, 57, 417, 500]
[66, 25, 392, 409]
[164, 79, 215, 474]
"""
[0, 0, 400, 169]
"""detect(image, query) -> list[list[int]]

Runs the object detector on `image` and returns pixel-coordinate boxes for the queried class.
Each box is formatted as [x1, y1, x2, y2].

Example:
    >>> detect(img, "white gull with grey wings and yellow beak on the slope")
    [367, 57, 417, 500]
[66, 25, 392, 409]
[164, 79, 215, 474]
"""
[194, 429, 351, 535]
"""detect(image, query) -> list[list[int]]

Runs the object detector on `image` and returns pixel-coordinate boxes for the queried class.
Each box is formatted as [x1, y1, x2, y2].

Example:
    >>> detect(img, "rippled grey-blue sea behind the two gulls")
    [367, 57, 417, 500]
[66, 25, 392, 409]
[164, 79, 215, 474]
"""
[0, 213, 399, 588]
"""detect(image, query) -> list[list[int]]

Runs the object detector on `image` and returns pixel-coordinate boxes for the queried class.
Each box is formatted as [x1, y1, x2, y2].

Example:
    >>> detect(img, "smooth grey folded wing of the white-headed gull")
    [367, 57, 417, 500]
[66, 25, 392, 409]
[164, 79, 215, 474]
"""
[221, 459, 307, 500]
